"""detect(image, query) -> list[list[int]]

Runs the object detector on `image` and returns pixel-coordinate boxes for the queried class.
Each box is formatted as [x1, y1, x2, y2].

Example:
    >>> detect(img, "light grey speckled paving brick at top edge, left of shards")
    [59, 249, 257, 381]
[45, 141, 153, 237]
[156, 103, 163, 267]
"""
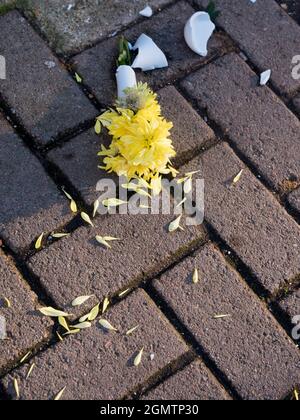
[26, 0, 172, 53]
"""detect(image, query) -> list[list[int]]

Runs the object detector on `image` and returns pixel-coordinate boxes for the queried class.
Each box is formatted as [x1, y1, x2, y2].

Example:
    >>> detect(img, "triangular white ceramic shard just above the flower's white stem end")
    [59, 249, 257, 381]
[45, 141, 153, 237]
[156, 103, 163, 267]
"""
[132, 34, 169, 71]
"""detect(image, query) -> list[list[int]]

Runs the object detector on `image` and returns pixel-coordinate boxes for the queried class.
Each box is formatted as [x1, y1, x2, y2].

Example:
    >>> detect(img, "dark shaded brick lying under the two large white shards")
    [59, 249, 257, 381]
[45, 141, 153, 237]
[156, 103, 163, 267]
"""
[74, 1, 227, 105]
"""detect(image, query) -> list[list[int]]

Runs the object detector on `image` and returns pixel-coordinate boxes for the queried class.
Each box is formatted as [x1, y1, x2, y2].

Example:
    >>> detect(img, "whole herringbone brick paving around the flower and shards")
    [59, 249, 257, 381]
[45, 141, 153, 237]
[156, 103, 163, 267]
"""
[0, 0, 300, 400]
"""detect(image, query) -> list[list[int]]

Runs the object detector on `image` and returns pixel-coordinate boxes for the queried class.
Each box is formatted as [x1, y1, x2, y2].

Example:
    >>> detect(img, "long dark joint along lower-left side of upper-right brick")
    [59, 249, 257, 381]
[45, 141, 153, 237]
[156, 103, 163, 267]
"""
[175, 83, 300, 224]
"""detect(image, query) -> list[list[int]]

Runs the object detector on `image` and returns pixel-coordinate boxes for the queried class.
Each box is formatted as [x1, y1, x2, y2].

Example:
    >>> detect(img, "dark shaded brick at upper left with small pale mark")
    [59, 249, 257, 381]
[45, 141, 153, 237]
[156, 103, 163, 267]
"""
[0, 12, 96, 144]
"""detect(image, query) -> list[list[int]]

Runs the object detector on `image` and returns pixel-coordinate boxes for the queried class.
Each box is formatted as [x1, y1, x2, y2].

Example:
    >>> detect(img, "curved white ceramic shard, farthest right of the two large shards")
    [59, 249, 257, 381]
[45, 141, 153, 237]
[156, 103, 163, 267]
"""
[184, 12, 216, 57]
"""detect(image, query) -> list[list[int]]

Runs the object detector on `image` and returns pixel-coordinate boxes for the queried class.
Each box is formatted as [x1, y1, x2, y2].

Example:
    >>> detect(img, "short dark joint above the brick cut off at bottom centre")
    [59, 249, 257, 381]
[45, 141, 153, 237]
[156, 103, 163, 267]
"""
[122, 349, 197, 400]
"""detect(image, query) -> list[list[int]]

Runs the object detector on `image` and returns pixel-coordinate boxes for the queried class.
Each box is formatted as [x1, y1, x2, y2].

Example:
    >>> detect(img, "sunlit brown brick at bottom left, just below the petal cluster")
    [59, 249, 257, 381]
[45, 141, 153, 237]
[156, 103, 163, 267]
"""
[4, 291, 188, 400]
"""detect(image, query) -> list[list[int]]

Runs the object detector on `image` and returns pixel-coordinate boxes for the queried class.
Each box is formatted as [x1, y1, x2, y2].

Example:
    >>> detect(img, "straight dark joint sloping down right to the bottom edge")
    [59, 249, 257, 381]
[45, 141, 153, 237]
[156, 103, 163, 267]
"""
[144, 284, 242, 400]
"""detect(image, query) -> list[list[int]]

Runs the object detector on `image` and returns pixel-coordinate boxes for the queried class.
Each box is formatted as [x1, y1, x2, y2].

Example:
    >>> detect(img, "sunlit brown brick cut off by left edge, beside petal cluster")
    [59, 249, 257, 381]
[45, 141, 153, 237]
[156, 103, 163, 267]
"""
[0, 251, 52, 374]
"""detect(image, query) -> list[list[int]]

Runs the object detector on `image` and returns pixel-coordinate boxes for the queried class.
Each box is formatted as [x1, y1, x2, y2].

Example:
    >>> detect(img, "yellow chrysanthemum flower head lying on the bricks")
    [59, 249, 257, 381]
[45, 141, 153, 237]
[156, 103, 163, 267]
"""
[98, 84, 176, 193]
